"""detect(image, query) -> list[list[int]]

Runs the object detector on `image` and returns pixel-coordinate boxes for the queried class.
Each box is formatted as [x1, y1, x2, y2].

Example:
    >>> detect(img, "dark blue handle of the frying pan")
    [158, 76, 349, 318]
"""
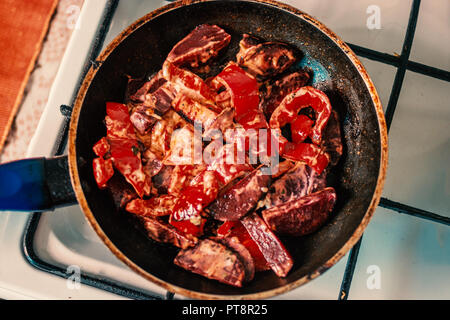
[0, 156, 76, 212]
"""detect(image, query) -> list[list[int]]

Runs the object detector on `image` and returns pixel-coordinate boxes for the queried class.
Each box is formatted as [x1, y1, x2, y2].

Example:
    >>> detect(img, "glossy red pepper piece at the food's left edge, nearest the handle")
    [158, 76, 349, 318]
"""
[108, 139, 151, 198]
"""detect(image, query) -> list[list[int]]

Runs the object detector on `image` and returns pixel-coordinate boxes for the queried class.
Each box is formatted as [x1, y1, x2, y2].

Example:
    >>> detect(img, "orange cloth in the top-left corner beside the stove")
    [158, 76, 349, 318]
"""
[0, 0, 58, 150]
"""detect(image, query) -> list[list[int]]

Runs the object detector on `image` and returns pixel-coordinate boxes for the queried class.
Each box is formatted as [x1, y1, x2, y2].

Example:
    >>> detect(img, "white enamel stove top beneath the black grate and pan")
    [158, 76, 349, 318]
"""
[0, 0, 450, 299]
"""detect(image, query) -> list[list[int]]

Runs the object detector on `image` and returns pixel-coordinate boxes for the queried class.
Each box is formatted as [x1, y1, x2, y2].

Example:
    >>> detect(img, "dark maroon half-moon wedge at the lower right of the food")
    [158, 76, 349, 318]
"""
[262, 187, 336, 236]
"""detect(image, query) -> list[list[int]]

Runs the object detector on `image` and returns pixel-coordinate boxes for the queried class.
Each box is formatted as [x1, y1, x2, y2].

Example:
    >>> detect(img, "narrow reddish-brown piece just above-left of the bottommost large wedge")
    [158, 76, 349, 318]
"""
[142, 217, 198, 249]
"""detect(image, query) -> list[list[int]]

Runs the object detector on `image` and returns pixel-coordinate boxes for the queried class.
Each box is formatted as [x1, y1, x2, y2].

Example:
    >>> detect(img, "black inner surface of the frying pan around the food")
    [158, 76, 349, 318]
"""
[75, 1, 381, 295]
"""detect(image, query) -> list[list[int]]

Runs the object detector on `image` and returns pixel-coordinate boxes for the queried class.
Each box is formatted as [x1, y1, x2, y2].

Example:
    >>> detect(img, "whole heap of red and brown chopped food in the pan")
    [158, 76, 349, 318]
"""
[93, 25, 342, 287]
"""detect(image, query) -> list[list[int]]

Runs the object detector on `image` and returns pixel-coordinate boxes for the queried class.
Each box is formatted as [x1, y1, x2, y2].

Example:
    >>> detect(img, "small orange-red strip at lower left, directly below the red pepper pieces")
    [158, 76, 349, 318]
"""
[126, 195, 177, 218]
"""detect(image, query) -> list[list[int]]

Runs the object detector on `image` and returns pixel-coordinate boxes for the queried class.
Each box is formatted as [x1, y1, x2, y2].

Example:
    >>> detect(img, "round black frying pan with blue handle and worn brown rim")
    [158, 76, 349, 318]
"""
[0, 0, 387, 299]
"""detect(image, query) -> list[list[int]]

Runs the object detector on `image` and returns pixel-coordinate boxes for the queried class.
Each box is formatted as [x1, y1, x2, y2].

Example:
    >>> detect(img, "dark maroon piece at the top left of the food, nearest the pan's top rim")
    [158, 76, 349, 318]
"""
[167, 24, 231, 67]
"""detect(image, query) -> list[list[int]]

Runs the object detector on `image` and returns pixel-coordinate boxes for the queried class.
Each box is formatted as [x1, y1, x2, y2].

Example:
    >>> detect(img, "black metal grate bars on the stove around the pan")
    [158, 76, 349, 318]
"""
[23, 0, 450, 300]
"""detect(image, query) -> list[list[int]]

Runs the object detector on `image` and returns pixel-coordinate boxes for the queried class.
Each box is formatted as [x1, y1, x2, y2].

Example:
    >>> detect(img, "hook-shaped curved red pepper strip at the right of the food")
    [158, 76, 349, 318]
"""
[270, 87, 331, 145]
